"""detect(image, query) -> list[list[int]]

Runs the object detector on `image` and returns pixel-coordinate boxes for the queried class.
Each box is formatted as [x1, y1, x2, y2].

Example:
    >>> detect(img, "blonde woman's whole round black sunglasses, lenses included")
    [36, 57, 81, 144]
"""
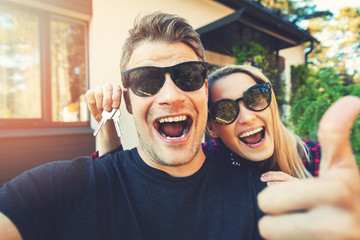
[209, 83, 271, 125]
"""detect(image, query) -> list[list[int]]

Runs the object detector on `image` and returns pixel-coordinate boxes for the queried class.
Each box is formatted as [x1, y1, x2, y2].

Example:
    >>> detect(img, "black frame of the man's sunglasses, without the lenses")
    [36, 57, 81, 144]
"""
[123, 61, 208, 97]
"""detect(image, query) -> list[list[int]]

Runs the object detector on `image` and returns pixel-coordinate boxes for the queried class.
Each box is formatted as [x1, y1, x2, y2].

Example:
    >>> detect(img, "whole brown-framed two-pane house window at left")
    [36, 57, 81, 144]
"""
[0, 4, 89, 128]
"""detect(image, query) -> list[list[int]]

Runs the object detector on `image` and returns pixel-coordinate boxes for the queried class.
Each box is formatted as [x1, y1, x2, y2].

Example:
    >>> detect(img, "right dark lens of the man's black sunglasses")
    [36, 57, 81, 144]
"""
[171, 63, 207, 92]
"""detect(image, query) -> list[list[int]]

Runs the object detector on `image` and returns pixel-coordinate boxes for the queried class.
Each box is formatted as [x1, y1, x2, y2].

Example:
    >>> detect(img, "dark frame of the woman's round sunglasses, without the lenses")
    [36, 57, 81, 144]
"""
[209, 82, 272, 125]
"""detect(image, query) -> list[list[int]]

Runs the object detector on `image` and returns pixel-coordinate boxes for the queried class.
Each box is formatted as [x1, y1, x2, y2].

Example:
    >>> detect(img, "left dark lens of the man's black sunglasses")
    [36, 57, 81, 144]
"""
[128, 67, 164, 97]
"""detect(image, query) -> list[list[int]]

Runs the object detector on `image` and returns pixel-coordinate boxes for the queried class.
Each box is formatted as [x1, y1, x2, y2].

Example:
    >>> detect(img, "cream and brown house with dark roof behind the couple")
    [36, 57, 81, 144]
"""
[0, 0, 311, 185]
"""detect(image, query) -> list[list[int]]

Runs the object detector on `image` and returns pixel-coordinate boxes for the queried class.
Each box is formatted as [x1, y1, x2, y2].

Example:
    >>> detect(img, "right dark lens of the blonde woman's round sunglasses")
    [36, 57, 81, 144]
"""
[243, 84, 271, 111]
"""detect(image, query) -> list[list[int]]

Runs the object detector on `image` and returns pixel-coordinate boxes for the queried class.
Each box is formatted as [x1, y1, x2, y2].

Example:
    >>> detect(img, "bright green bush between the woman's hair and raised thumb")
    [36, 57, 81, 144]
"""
[289, 65, 360, 166]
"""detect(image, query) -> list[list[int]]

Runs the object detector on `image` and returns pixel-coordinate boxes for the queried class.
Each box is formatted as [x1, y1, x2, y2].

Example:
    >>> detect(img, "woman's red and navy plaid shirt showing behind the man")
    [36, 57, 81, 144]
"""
[91, 140, 321, 177]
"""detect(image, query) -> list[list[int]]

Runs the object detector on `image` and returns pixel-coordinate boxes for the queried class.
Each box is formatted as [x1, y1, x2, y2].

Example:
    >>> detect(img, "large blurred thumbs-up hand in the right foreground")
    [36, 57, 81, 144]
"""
[258, 96, 360, 240]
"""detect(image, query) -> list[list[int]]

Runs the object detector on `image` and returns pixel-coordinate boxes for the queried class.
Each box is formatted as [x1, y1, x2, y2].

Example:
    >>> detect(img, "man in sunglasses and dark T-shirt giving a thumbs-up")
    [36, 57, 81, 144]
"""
[0, 13, 360, 239]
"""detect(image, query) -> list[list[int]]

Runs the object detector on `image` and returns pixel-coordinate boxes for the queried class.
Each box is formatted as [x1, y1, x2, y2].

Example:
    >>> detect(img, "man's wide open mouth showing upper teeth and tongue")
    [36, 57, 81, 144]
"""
[154, 115, 193, 139]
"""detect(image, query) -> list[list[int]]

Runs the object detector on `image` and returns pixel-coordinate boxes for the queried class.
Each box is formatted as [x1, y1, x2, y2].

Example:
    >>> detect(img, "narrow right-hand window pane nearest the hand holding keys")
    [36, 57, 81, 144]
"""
[50, 16, 88, 122]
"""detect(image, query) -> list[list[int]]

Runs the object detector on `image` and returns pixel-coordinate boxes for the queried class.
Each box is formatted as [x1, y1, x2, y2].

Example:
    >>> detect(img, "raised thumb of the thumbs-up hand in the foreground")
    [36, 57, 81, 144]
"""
[318, 96, 360, 177]
